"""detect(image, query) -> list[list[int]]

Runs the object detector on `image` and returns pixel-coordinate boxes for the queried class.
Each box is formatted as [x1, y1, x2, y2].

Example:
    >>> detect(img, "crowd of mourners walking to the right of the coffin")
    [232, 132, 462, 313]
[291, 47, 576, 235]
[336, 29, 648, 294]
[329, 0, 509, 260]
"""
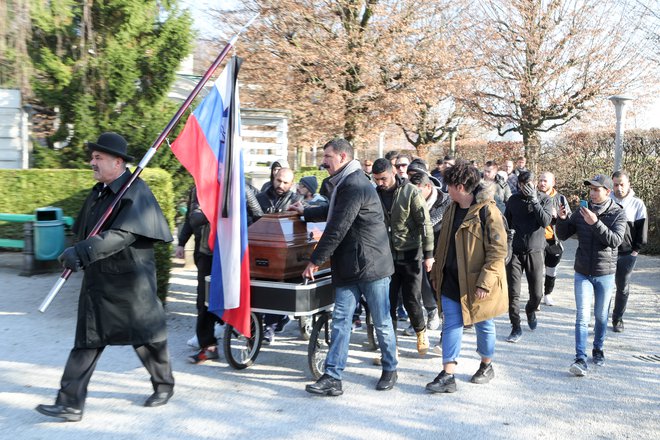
[289, 140, 648, 395]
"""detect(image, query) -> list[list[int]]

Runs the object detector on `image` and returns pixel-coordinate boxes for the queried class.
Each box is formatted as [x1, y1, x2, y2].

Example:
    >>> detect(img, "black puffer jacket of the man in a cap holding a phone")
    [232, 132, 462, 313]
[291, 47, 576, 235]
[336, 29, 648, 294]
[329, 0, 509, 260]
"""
[556, 199, 626, 276]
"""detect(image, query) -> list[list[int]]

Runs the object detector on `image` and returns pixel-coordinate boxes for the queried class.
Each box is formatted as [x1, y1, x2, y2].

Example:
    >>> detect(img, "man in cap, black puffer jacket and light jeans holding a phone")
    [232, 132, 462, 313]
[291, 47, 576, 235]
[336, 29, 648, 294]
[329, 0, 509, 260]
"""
[557, 174, 626, 376]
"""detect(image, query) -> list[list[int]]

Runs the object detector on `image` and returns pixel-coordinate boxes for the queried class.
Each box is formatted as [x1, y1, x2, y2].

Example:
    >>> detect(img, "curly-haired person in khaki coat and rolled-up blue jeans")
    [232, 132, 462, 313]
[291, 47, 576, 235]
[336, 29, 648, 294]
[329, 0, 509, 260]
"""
[426, 160, 508, 393]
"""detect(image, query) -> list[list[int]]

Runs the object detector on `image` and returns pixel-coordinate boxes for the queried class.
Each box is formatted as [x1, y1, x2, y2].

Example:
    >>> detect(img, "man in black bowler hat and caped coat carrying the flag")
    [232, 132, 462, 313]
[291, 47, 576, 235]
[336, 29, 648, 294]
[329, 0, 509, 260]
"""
[36, 132, 174, 422]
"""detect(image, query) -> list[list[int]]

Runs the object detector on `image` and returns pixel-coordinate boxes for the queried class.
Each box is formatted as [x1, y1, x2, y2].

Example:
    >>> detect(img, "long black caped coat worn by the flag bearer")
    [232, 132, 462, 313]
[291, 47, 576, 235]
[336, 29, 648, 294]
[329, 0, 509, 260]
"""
[73, 171, 172, 348]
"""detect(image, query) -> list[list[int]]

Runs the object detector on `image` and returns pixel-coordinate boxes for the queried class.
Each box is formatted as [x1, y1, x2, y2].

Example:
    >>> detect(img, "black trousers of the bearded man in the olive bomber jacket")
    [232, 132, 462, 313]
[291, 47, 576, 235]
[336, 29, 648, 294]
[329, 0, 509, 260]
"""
[390, 260, 426, 332]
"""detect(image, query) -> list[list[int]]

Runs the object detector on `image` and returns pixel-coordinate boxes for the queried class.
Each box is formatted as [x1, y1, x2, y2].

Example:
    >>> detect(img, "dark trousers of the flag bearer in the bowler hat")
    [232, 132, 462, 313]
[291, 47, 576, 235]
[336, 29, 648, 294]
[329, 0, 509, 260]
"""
[56, 341, 174, 409]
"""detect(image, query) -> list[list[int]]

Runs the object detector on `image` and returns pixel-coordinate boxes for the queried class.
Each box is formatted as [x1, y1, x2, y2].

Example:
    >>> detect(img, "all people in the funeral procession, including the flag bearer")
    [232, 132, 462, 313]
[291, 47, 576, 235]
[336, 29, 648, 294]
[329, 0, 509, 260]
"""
[36, 133, 648, 421]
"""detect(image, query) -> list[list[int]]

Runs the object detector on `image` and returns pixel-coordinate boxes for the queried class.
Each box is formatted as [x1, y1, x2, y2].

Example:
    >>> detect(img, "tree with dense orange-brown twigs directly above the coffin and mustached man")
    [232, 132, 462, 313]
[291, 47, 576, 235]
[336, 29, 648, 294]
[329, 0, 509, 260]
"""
[215, 0, 464, 156]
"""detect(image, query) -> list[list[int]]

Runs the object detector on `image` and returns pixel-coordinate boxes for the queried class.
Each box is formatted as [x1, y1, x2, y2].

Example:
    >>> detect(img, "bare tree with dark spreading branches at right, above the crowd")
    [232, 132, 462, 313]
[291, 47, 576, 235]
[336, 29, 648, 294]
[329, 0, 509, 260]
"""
[465, 0, 657, 168]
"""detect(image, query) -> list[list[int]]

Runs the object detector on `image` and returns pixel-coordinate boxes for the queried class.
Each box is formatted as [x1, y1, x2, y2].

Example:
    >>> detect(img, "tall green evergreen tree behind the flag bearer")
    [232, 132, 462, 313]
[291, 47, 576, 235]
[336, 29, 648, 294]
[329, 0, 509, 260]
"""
[30, 0, 193, 167]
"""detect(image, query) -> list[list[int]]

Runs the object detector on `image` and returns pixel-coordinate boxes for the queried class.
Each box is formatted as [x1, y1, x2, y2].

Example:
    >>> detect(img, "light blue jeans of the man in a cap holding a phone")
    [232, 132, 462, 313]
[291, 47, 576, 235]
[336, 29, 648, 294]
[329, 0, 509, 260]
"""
[573, 272, 614, 360]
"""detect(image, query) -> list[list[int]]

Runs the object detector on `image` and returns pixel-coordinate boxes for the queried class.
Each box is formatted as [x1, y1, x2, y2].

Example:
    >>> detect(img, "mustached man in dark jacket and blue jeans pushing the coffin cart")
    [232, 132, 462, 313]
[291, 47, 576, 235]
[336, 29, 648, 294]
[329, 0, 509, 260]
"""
[291, 139, 397, 396]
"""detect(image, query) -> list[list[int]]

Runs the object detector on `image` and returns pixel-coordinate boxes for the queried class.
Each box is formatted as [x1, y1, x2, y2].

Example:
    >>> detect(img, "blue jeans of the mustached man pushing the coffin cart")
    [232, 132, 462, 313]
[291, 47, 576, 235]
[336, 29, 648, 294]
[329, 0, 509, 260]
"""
[325, 277, 397, 380]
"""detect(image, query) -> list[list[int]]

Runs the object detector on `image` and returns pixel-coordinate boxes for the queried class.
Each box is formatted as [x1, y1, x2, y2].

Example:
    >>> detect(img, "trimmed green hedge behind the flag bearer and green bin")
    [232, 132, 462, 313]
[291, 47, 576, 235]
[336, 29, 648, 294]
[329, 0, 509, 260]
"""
[0, 168, 175, 301]
